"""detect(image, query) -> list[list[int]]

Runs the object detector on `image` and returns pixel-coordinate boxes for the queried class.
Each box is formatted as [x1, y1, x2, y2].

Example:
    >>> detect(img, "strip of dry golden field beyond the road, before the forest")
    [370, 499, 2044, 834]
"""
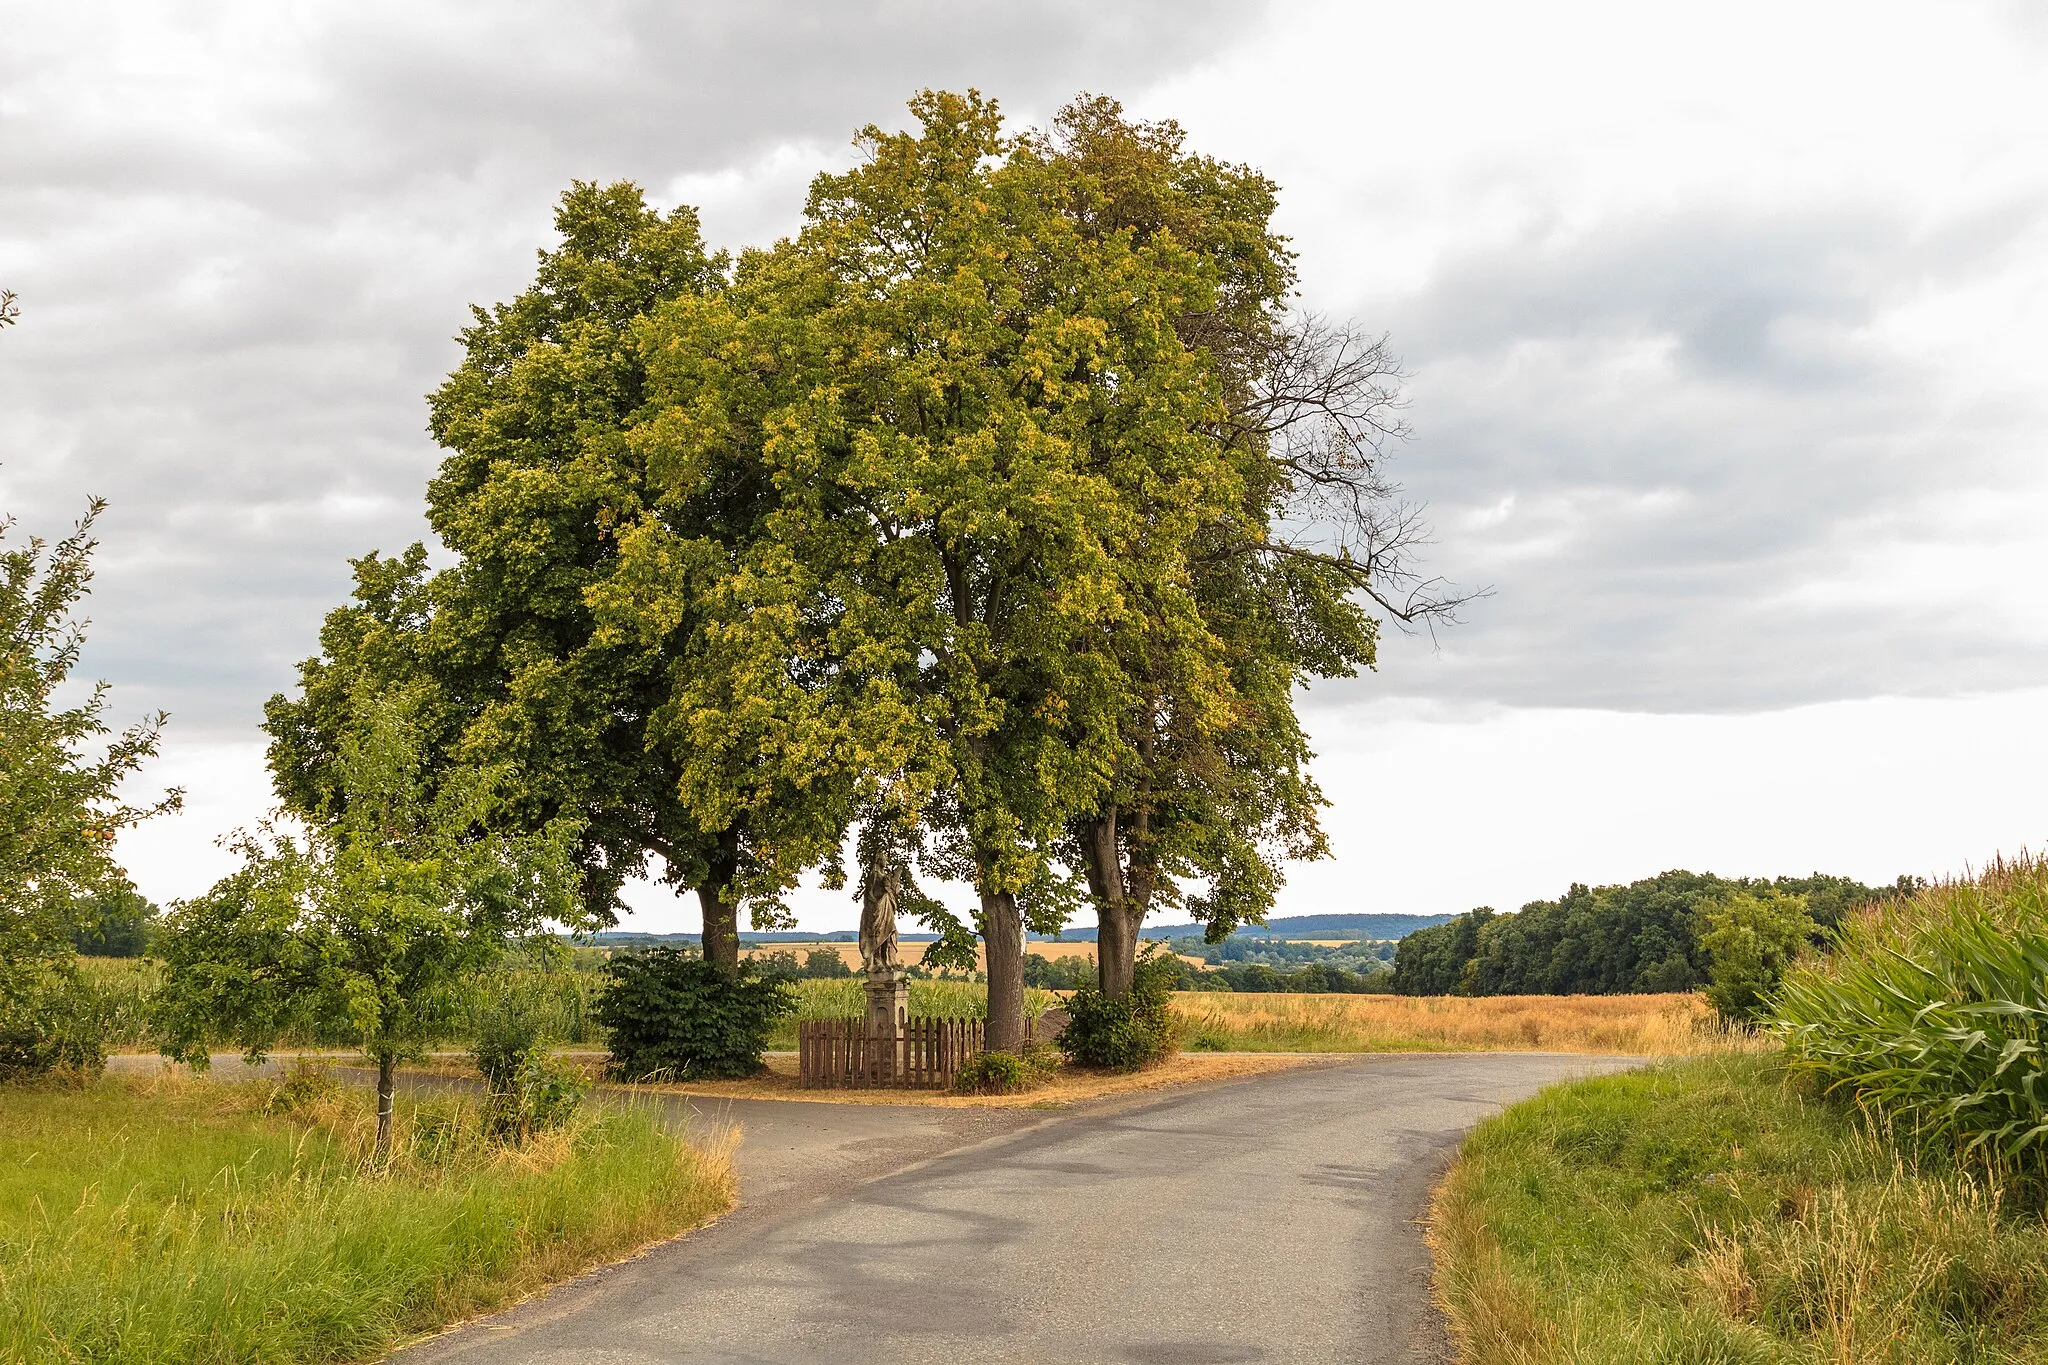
[1174, 990, 1772, 1056]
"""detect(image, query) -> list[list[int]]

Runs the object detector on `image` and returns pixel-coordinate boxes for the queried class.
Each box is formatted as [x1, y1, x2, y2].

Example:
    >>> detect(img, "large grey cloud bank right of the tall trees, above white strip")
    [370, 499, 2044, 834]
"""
[1319, 194, 2048, 710]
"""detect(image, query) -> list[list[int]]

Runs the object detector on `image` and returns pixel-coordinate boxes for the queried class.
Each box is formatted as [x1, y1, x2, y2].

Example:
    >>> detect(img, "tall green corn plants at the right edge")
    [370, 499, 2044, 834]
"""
[1778, 857, 2048, 1185]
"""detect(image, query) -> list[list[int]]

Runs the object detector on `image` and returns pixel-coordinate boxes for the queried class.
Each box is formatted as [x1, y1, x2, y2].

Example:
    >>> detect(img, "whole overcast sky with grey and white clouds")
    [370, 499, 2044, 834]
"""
[0, 0, 2048, 927]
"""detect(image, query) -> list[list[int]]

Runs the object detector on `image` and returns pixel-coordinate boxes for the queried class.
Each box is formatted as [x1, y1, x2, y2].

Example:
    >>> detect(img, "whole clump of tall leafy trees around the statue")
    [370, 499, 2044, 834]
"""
[268, 92, 1456, 1046]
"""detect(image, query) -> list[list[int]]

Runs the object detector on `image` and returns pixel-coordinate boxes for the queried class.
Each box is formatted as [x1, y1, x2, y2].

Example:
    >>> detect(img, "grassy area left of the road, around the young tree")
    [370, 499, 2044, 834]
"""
[0, 1081, 731, 1365]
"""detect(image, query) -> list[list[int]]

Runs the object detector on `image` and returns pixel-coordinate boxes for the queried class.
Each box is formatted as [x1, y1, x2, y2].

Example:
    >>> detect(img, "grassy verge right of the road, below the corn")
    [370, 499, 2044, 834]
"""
[1432, 1056, 2048, 1365]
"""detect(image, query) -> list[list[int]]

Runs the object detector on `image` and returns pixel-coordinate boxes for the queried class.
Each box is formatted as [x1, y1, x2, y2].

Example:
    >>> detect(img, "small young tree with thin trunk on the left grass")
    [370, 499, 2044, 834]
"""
[158, 696, 580, 1156]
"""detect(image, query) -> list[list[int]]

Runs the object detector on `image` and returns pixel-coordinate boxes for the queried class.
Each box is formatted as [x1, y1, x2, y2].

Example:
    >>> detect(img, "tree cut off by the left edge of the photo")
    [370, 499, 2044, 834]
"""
[0, 499, 180, 1070]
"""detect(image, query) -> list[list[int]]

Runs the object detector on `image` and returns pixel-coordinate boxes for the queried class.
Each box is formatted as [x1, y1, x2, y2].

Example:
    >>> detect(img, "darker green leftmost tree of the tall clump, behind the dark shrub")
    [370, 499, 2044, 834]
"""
[266, 184, 829, 972]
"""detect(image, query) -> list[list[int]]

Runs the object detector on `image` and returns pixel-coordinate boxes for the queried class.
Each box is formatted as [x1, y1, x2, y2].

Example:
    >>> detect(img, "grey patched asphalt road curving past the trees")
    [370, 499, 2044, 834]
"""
[393, 1054, 1630, 1365]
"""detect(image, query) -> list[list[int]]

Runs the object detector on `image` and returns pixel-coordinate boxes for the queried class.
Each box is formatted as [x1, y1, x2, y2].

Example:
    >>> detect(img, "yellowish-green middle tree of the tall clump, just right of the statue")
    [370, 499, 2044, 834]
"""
[712, 92, 1241, 1048]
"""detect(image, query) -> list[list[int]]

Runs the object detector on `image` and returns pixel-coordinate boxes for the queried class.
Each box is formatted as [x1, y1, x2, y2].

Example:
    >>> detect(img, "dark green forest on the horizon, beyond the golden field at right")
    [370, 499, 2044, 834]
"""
[1393, 872, 1917, 995]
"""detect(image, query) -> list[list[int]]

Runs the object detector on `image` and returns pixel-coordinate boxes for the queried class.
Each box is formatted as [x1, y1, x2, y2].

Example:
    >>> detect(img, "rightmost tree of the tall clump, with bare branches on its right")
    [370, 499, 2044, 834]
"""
[1024, 96, 1462, 999]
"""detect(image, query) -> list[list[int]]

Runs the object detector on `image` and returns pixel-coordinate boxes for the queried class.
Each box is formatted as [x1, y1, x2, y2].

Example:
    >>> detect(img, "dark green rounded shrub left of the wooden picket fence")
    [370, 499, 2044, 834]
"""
[596, 948, 797, 1081]
